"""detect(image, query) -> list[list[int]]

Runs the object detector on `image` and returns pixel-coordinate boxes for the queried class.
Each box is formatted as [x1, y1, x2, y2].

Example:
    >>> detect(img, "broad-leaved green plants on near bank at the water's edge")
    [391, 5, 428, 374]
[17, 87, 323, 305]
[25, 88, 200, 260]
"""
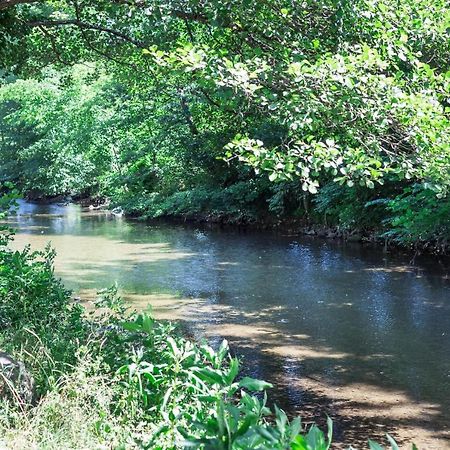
[114, 313, 331, 450]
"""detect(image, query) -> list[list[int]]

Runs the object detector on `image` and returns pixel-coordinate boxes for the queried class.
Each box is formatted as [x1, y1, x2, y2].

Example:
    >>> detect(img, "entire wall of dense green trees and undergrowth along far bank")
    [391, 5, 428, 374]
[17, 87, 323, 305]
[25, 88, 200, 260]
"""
[0, 0, 450, 248]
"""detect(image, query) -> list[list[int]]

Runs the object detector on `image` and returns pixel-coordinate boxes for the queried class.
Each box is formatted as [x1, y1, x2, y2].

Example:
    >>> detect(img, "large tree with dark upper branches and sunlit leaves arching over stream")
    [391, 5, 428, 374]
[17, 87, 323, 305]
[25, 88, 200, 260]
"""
[0, 0, 450, 244]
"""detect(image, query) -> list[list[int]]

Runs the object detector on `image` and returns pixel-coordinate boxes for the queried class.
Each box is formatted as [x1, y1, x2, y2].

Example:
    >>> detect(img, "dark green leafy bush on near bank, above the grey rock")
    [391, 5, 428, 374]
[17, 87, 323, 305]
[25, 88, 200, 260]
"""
[0, 244, 86, 393]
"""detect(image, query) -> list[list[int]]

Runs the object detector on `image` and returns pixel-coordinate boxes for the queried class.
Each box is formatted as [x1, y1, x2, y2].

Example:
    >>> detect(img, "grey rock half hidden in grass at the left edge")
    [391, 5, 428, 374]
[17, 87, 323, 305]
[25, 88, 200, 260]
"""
[0, 352, 34, 406]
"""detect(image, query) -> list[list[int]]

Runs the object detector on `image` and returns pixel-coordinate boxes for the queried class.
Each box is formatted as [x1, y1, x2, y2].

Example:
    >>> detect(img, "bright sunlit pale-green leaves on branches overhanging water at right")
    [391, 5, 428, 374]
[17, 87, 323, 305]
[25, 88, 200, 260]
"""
[222, 33, 450, 195]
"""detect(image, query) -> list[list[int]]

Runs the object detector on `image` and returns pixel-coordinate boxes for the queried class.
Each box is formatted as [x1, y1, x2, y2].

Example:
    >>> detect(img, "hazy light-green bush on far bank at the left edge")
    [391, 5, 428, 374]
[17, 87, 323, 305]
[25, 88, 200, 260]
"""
[0, 67, 118, 197]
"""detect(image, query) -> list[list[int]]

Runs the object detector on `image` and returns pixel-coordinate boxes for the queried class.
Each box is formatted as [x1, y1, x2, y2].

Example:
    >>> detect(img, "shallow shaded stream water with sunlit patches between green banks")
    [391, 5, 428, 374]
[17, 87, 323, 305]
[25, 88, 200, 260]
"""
[6, 202, 450, 449]
